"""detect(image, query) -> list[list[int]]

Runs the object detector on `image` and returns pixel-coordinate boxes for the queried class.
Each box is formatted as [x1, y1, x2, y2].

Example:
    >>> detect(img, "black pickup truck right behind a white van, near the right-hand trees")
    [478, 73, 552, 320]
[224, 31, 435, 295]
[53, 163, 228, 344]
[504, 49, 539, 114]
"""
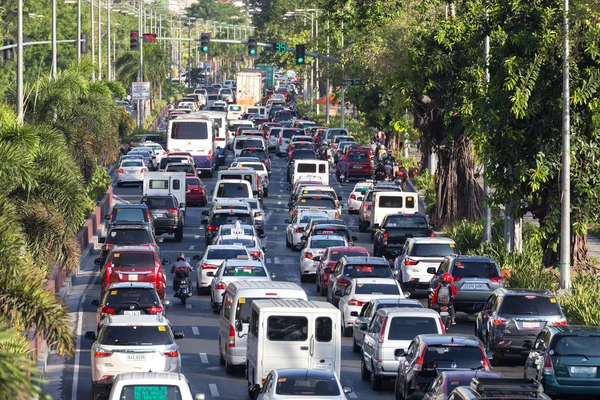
[373, 213, 435, 259]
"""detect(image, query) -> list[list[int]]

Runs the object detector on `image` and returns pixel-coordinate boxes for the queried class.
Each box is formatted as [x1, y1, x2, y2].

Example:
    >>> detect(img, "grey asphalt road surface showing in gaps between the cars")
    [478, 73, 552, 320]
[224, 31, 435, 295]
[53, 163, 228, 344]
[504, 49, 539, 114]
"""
[61, 155, 523, 399]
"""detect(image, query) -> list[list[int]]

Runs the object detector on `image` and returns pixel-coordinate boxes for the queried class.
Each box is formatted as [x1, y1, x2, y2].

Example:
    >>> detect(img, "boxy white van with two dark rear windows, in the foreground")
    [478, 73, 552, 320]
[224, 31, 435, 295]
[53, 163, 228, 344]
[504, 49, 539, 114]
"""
[244, 299, 342, 388]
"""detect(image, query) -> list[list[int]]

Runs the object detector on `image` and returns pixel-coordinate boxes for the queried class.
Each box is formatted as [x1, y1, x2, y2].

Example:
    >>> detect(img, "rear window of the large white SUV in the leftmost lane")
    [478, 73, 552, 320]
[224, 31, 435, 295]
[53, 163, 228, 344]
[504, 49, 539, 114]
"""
[98, 325, 173, 346]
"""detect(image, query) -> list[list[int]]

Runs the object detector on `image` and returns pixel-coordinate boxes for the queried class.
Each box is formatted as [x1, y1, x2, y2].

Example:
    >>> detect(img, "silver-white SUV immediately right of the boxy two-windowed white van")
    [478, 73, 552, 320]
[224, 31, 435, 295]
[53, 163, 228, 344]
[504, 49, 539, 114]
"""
[359, 308, 446, 391]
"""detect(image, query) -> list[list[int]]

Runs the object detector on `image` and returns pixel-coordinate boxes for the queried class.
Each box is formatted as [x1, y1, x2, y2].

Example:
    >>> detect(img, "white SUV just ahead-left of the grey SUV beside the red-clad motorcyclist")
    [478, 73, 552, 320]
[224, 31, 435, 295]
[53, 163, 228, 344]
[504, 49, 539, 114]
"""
[394, 237, 458, 292]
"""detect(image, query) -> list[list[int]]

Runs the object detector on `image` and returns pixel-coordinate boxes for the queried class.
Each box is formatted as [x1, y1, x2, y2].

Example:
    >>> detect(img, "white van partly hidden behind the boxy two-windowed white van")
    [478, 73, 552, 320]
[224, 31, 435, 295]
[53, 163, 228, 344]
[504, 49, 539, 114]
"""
[219, 281, 308, 373]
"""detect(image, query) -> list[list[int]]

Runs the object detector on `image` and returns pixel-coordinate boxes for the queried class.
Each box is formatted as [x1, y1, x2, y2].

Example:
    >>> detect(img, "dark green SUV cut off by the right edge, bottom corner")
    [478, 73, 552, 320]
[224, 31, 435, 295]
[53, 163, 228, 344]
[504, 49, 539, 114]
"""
[523, 325, 600, 398]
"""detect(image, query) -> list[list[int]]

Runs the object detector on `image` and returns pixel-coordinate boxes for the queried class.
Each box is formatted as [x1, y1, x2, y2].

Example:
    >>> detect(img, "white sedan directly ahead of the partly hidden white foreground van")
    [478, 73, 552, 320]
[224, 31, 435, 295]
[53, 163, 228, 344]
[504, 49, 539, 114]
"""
[210, 260, 276, 313]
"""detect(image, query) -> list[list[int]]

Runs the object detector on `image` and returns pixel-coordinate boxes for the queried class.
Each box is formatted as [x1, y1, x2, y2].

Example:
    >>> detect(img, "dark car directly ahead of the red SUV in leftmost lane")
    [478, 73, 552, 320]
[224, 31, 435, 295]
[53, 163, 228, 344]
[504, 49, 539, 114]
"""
[98, 223, 161, 262]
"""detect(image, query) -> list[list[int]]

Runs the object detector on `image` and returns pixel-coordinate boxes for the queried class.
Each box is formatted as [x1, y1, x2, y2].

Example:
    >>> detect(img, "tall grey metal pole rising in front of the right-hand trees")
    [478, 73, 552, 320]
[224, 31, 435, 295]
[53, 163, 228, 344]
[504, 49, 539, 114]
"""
[558, 0, 571, 292]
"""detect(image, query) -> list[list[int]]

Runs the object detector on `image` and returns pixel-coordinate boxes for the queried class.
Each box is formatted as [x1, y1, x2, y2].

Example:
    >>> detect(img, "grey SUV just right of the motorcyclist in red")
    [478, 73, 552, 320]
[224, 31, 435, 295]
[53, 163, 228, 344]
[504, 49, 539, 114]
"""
[427, 255, 504, 314]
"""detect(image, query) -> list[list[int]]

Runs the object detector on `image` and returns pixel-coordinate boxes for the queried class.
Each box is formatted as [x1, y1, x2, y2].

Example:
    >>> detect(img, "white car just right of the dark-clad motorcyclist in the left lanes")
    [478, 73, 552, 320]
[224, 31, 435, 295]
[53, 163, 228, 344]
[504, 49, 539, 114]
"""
[196, 245, 250, 295]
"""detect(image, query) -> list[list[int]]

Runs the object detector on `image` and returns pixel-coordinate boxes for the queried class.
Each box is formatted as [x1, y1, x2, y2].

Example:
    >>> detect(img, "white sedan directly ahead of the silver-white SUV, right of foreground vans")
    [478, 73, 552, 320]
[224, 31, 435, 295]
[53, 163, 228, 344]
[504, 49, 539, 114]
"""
[338, 278, 405, 337]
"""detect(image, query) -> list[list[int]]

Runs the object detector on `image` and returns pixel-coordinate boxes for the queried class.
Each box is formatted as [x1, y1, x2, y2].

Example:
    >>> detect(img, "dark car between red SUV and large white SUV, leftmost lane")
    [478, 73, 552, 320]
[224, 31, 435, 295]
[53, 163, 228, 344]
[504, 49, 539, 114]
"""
[90, 282, 170, 328]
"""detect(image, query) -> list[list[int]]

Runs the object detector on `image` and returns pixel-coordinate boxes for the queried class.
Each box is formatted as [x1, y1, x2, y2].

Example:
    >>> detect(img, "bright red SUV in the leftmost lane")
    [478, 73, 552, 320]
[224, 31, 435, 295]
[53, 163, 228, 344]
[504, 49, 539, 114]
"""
[94, 246, 171, 299]
